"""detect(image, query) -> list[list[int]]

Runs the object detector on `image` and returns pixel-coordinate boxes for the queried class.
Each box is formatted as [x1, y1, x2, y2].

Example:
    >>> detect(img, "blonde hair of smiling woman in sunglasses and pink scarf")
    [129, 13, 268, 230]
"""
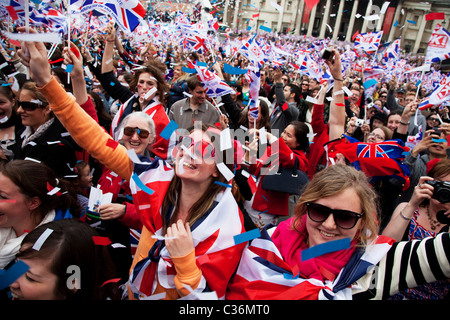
[294, 164, 379, 246]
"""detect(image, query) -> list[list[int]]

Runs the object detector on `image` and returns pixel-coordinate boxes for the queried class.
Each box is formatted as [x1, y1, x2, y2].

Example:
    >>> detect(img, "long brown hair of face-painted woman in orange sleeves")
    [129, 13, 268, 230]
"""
[161, 124, 233, 232]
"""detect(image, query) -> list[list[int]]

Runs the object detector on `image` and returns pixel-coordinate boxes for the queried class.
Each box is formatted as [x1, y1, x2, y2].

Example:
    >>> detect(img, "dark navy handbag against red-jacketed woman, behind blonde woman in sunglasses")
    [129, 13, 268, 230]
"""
[261, 157, 309, 195]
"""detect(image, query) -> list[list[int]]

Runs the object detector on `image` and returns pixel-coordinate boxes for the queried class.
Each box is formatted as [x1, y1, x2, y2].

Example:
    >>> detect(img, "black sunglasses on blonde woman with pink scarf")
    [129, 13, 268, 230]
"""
[306, 202, 362, 229]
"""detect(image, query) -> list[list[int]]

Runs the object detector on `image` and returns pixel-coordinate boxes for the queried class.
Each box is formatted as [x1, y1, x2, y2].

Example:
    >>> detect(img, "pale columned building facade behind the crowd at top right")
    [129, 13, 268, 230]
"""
[221, 0, 450, 54]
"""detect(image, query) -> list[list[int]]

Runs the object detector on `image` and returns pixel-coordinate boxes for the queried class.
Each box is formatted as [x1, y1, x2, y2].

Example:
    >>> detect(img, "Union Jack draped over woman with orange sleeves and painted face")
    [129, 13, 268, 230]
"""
[128, 159, 245, 299]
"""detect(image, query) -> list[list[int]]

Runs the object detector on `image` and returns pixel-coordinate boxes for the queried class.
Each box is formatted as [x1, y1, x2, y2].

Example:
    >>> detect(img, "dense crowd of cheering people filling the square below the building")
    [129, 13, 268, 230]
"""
[0, 8, 450, 300]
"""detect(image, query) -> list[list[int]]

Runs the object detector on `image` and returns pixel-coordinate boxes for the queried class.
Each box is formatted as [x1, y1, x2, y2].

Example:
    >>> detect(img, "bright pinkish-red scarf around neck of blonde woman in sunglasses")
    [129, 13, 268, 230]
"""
[271, 215, 356, 281]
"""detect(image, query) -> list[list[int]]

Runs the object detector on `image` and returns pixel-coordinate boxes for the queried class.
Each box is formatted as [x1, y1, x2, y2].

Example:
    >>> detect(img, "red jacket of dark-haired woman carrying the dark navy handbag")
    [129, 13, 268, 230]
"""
[250, 139, 308, 216]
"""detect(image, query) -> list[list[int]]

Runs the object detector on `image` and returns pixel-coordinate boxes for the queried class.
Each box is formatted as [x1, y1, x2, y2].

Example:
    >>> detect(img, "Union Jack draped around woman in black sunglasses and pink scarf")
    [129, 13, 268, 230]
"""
[226, 222, 393, 300]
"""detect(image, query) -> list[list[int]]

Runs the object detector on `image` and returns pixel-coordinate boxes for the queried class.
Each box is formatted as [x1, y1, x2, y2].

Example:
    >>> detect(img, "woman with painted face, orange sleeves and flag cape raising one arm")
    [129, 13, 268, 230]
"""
[18, 28, 245, 299]
